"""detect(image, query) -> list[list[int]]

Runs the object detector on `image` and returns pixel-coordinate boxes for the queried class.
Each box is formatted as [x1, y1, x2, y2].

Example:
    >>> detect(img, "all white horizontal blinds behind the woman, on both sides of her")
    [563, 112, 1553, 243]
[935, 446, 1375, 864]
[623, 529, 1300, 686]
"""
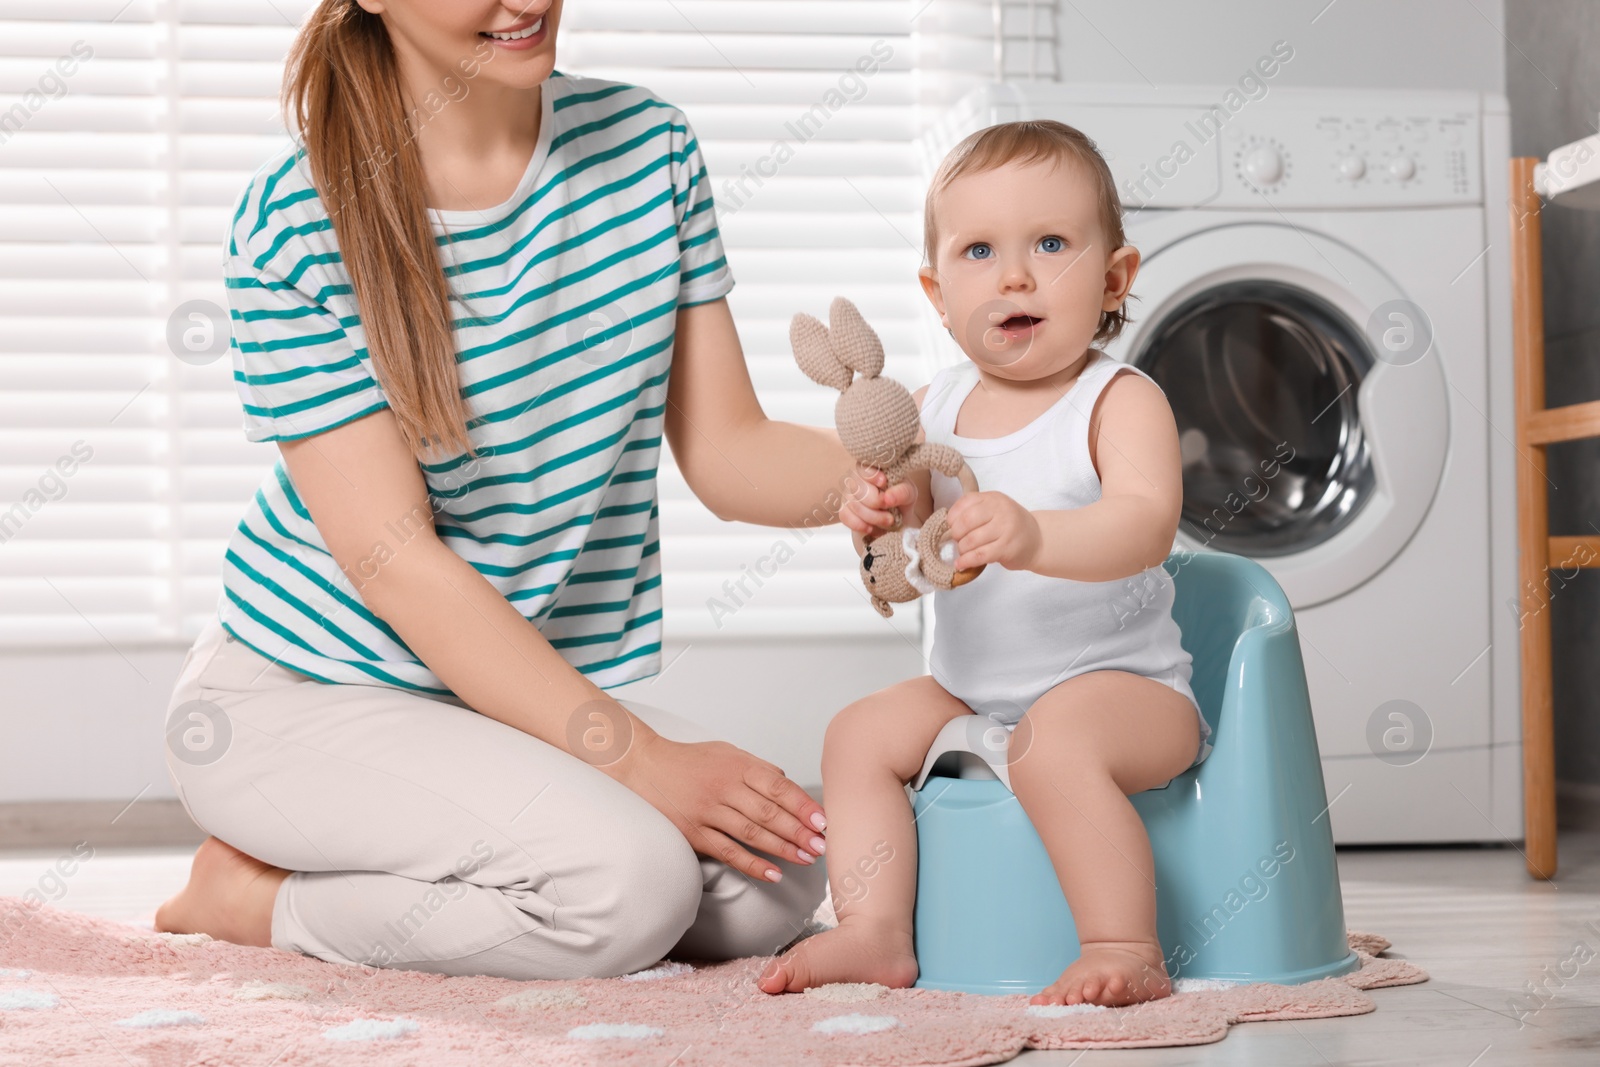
[0, 0, 926, 649]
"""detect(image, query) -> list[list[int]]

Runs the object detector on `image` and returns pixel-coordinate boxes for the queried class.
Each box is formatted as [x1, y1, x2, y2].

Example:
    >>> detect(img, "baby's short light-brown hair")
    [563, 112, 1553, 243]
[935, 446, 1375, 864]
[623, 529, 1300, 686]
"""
[922, 118, 1128, 342]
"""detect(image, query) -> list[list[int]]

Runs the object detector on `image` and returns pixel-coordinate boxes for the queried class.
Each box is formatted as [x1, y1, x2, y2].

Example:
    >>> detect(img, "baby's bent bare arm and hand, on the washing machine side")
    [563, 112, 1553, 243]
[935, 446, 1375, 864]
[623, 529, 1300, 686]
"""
[950, 373, 1184, 582]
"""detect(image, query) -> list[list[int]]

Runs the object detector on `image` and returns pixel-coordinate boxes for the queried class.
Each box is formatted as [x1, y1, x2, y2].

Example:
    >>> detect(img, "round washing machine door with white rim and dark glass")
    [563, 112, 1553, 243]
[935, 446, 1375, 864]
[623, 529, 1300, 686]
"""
[1112, 224, 1450, 608]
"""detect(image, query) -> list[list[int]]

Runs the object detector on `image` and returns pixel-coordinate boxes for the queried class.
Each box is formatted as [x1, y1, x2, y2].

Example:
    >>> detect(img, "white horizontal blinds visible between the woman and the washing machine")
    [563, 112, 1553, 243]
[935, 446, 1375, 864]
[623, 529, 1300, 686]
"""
[557, 0, 926, 637]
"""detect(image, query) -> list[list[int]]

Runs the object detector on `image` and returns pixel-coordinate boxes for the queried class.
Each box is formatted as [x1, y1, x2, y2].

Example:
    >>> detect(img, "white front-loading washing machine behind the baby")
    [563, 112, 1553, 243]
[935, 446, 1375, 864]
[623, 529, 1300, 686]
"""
[920, 83, 1523, 843]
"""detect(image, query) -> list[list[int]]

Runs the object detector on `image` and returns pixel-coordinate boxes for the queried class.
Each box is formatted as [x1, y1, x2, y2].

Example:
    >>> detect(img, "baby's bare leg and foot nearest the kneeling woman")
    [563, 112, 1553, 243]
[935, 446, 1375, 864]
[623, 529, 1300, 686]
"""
[757, 677, 971, 993]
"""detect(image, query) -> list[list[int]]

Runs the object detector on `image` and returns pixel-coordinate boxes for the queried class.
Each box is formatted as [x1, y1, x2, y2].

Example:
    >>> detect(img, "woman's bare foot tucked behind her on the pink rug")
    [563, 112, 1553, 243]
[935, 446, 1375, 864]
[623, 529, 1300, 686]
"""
[155, 837, 290, 949]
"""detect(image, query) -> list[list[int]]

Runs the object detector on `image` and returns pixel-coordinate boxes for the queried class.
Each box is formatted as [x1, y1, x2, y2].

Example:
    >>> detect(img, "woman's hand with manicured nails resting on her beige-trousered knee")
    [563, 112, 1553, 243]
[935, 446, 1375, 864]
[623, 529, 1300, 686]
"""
[602, 731, 827, 881]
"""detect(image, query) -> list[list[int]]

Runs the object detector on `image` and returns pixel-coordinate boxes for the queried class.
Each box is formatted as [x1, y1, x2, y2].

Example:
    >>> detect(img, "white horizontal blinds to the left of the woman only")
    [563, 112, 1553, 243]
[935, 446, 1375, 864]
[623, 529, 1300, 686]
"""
[0, 0, 310, 649]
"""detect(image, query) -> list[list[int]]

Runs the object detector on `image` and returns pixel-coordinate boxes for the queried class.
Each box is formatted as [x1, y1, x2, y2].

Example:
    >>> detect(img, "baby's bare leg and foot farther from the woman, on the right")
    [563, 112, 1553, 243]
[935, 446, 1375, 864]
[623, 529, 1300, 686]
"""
[1010, 670, 1200, 1005]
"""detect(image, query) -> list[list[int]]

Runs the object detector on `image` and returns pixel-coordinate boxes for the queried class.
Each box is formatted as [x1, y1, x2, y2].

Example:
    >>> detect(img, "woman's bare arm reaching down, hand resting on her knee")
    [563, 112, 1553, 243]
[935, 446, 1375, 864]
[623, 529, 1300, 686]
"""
[278, 410, 821, 878]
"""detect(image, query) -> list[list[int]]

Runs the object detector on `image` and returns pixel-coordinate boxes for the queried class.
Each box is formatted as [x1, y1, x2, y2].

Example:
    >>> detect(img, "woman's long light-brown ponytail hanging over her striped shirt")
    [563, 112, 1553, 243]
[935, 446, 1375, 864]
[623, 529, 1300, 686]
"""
[282, 0, 472, 456]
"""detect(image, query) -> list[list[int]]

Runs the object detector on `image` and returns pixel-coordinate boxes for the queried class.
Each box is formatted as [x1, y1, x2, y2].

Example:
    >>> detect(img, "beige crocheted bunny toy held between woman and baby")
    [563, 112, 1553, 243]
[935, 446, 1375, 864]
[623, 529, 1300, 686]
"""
[789, 296, 984, 617]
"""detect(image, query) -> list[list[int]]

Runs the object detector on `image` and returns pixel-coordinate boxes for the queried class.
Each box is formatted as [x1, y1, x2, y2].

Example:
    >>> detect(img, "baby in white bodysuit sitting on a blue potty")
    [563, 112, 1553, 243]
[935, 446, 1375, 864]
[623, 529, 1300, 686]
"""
[758, 122, 1210, 1005]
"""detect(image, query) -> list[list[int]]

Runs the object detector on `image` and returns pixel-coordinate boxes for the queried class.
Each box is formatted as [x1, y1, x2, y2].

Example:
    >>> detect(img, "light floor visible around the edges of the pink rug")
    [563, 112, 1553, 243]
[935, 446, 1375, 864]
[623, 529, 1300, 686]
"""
[0, 833, 1600, 1067]
